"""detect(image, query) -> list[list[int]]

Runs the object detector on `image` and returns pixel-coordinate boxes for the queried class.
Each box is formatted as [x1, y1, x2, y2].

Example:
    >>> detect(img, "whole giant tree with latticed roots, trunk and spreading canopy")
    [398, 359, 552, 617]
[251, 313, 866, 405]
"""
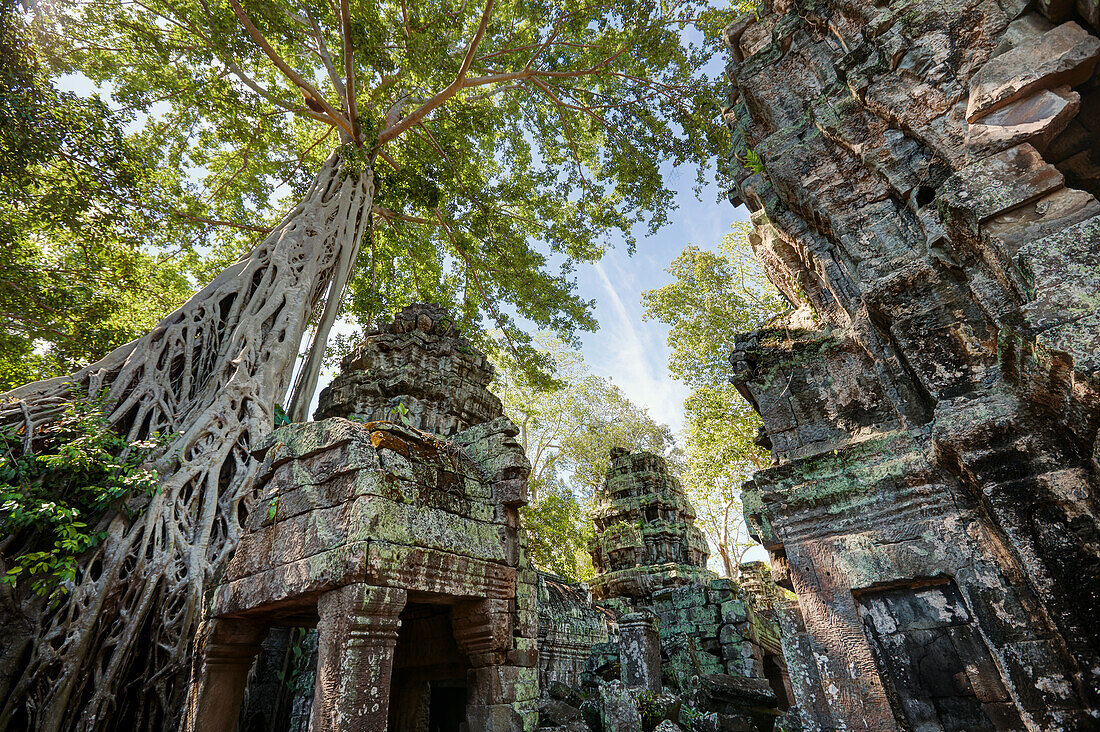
[0, 0, 739, 730]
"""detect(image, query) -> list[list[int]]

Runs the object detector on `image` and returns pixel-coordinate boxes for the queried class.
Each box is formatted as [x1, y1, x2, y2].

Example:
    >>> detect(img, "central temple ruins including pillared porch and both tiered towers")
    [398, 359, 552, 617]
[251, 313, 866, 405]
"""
[186, 305, 788, 732]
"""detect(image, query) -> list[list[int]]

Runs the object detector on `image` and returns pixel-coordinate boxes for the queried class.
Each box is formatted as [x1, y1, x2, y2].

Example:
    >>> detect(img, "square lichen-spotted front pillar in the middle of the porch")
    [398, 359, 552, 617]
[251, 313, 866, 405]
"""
[309, 583, 405, 732]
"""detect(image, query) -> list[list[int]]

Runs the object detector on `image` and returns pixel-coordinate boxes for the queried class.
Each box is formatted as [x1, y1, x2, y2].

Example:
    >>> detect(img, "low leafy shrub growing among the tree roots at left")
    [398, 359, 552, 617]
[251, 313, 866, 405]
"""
[0, 401, 158, 601]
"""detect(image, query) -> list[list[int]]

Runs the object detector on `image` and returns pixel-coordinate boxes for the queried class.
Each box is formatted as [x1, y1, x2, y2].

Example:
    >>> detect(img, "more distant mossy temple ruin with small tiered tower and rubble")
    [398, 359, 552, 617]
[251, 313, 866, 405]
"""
[530, 449, 790, 732]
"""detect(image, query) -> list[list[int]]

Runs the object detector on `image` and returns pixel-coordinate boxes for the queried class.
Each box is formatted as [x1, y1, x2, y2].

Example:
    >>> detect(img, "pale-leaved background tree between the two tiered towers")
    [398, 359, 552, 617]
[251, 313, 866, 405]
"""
[493, 338, 674, 581]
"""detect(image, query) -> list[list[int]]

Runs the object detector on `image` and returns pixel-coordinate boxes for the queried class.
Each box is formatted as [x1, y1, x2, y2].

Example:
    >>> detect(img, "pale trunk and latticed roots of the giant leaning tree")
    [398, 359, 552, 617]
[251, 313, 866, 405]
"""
[0, 154, 374, 731]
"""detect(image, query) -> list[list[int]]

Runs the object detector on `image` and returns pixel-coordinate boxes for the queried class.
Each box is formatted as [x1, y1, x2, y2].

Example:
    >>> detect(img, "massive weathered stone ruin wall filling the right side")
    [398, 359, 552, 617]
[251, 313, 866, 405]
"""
[725, 0, 1100, 731]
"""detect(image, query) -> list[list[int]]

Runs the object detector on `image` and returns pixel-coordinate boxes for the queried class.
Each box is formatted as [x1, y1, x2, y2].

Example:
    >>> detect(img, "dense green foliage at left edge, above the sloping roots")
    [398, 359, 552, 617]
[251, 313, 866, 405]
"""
[0, 0, 202, 391]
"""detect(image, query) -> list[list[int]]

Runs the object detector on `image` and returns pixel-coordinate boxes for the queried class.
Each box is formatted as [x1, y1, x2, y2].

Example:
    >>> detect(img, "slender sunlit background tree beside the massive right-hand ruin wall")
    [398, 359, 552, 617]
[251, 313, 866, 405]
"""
[642, 222, 785, 579]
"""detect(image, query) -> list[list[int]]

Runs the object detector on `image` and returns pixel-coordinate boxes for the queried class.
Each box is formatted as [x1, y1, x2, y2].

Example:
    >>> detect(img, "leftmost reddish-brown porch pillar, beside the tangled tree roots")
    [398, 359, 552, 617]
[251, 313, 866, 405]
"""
[184, 618, 267, 732]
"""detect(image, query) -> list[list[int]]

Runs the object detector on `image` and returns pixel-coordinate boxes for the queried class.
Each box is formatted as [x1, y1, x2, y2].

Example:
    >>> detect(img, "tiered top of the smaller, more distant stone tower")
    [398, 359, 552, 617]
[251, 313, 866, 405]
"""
[589, 448, 714, 600]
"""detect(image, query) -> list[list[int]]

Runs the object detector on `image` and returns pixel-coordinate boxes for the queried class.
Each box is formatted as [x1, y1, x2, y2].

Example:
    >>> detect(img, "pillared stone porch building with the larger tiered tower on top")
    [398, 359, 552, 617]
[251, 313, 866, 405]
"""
[187, 306, 538, 732]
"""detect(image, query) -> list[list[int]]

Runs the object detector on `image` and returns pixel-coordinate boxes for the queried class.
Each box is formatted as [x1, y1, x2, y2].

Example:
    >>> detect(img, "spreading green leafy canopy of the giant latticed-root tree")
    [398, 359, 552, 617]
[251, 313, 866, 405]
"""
[19, 0, 739, 383]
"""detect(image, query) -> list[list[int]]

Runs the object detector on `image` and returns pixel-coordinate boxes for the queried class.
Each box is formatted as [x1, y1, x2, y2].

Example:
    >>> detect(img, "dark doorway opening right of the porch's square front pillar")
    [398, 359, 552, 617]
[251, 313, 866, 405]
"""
[388, 602, 470, 732]
